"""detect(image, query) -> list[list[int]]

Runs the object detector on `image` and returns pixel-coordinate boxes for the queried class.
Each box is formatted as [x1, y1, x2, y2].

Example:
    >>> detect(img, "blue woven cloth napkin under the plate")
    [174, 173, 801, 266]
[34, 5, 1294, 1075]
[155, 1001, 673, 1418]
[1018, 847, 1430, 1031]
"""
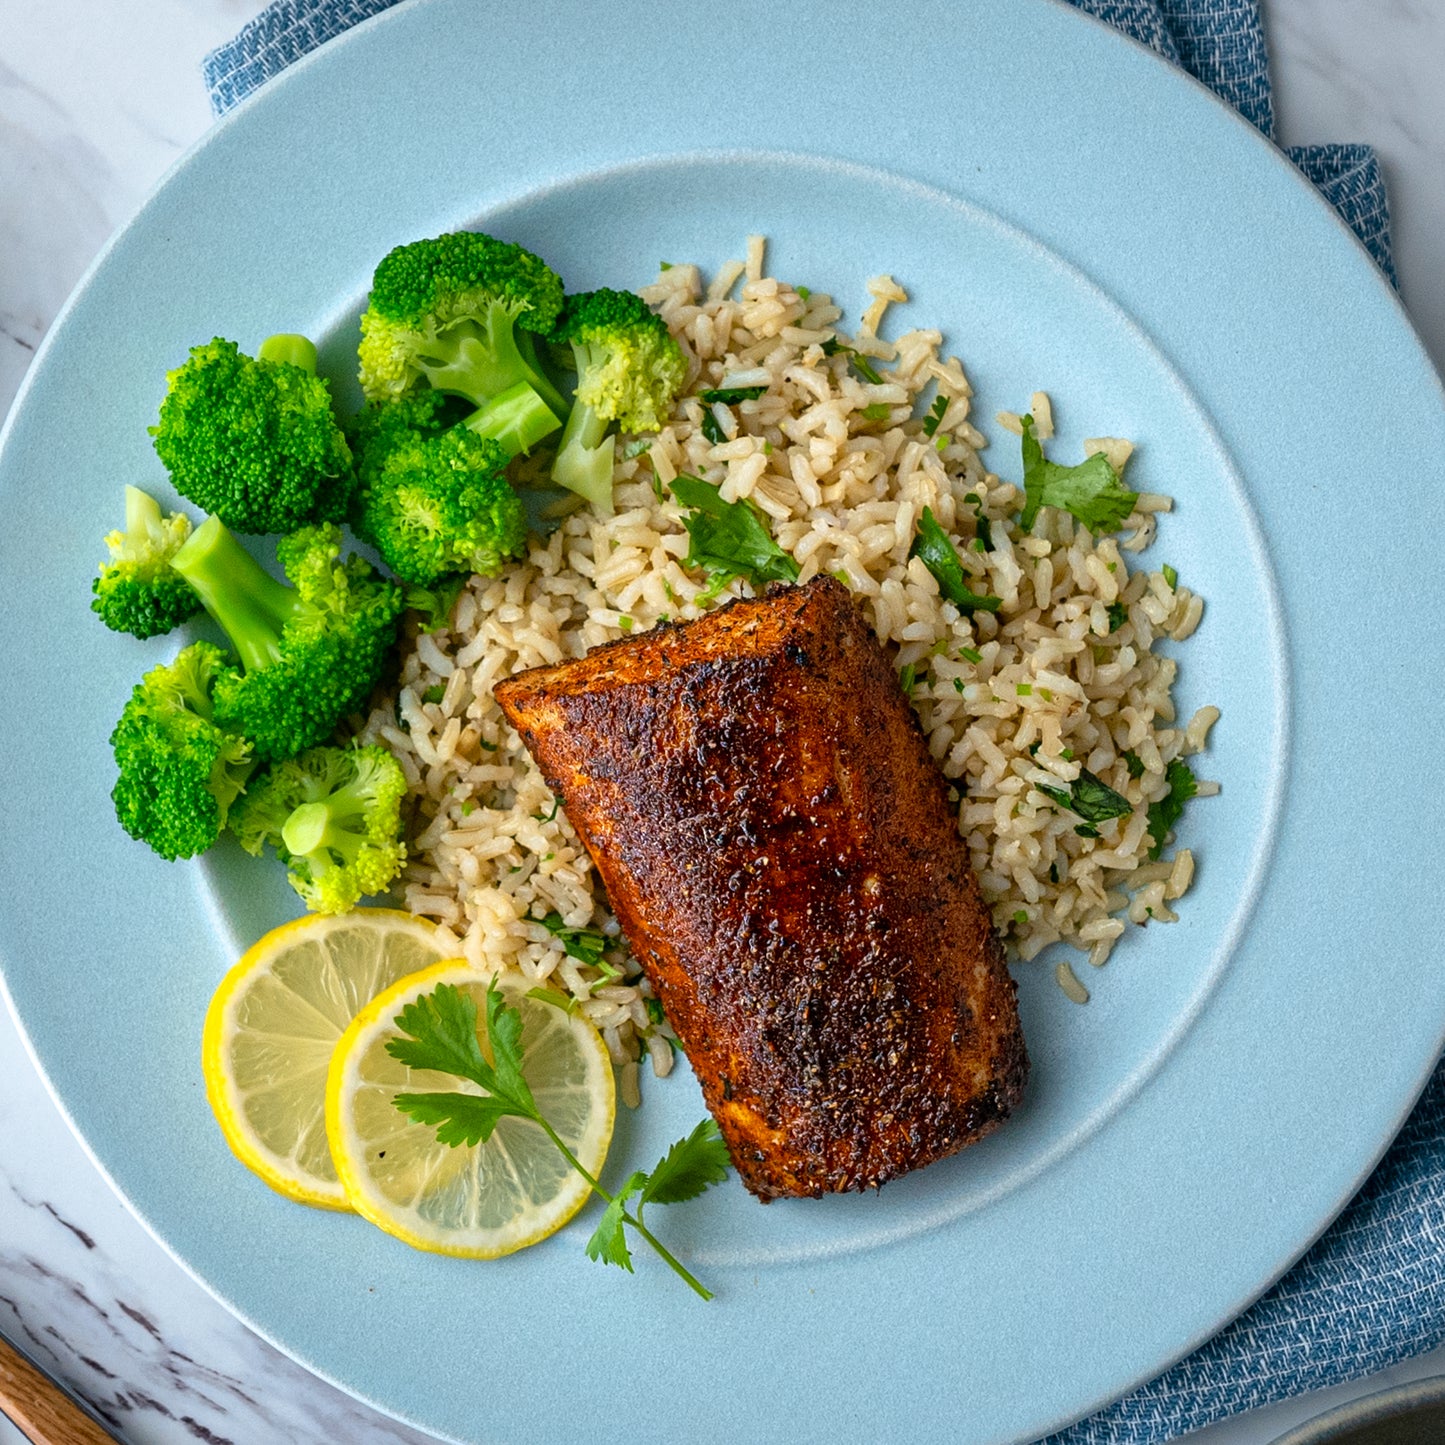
[205, 0, 1445, 1445]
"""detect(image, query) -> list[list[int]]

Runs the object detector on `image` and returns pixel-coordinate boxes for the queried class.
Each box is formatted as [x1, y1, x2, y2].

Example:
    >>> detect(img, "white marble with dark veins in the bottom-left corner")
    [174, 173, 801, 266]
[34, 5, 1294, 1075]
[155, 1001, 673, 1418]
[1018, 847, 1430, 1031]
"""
[0, 1013, 428, 1445]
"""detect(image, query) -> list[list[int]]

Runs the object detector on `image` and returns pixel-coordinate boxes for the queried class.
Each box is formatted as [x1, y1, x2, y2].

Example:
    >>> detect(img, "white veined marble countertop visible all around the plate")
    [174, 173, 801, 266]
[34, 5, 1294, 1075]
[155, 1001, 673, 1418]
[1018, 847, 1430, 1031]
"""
[0, 0, 1445, 1445]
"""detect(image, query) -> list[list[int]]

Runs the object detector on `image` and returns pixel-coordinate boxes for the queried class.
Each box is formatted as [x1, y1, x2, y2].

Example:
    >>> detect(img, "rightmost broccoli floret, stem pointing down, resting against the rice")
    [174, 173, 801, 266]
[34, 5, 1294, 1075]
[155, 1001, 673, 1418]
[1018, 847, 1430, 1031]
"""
[552, 290, 688, 512]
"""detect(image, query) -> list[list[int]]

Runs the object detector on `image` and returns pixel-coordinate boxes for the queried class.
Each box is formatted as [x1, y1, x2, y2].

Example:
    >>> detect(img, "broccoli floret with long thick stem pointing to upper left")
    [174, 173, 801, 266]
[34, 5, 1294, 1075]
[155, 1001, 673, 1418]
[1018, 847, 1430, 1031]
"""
[173, 517, 402, 762]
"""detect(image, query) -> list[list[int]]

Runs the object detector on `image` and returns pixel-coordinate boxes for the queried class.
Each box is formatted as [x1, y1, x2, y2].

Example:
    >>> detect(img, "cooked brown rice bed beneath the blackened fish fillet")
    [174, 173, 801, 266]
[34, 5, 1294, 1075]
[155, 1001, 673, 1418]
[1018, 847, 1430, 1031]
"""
[355, 237, 1218, 1051]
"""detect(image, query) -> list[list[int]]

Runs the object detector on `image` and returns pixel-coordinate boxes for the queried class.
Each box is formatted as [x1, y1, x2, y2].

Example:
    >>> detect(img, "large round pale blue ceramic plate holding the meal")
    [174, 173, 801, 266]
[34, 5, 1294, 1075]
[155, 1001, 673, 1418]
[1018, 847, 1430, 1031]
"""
[0, 0, 1445, 1442]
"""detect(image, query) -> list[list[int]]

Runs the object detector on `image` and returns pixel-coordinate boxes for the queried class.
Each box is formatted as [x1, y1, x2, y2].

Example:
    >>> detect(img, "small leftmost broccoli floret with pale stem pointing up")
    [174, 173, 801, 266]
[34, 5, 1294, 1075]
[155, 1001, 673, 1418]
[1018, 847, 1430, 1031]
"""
[91, 487, 201, 637]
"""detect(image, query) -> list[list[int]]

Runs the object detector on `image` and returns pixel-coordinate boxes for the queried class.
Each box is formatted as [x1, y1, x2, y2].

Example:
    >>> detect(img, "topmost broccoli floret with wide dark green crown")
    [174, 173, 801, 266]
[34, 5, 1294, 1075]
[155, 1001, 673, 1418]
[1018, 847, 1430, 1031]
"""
[360, 231, 566, 418]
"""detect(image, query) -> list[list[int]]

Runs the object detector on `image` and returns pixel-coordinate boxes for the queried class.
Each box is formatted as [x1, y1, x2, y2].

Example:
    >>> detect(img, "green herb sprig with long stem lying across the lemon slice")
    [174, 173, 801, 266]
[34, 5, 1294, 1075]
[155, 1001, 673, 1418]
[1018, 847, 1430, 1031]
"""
[386, 980, 728, 1299]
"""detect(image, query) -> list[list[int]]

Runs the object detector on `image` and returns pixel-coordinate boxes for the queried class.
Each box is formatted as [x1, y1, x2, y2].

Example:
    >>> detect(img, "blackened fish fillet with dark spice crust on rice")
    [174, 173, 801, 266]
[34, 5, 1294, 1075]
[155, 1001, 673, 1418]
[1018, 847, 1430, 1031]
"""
[496, 578, 1027, 1198]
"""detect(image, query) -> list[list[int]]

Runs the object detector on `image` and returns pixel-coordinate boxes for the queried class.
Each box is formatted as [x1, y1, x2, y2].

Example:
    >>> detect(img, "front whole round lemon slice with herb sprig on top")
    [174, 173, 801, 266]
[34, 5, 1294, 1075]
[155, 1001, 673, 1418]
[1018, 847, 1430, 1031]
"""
[327, 959, 617, 1259]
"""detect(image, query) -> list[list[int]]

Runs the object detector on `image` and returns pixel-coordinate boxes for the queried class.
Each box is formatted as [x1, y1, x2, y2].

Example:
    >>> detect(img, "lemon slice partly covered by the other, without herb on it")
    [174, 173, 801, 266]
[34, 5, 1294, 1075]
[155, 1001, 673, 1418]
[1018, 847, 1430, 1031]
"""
[201, 909, 445, 1209]
